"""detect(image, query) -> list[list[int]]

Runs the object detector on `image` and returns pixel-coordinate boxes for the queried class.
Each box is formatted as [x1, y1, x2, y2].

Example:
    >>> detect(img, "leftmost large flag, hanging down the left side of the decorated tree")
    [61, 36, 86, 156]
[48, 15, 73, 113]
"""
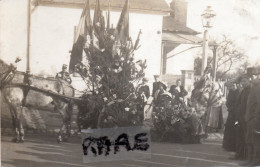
[69, 0, 93, 73]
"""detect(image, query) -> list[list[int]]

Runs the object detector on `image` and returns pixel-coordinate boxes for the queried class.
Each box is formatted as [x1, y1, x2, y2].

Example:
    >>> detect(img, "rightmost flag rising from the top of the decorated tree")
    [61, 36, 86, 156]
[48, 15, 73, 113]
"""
[116, 0, 129, 43]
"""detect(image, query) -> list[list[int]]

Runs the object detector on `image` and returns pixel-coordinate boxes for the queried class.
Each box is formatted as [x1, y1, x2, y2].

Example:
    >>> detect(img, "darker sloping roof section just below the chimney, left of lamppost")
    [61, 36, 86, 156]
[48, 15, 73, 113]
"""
[163, 16, 199, 35]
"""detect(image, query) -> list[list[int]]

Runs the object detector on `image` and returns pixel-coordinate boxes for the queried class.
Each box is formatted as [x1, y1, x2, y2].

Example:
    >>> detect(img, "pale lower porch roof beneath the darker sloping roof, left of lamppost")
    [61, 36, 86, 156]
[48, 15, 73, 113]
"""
[162, 32, 203, 45]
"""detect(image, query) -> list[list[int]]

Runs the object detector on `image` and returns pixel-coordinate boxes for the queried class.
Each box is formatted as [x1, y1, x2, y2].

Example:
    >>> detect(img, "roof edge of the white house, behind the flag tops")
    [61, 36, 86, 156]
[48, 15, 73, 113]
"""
[38, 0, 170, 14]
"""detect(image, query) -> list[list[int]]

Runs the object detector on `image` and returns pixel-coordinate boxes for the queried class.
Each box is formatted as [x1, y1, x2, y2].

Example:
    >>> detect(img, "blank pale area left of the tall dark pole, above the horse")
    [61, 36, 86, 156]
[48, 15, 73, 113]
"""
[0, 0, 26, 69]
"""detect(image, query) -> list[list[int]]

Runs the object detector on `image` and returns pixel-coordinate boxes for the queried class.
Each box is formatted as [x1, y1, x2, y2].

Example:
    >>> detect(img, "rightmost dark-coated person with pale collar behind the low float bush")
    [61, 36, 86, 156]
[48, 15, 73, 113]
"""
[169, 79, 188, 101]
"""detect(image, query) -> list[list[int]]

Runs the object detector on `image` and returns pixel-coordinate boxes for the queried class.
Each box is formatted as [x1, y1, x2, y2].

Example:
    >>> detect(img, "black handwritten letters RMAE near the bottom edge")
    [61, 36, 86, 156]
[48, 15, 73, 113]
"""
[82, 133, 150, 156]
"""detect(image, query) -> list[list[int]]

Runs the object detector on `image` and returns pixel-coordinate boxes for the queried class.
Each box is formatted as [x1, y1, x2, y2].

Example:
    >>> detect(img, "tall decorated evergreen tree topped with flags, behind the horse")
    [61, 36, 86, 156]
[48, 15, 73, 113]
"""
[70, 0, 146, 128]
